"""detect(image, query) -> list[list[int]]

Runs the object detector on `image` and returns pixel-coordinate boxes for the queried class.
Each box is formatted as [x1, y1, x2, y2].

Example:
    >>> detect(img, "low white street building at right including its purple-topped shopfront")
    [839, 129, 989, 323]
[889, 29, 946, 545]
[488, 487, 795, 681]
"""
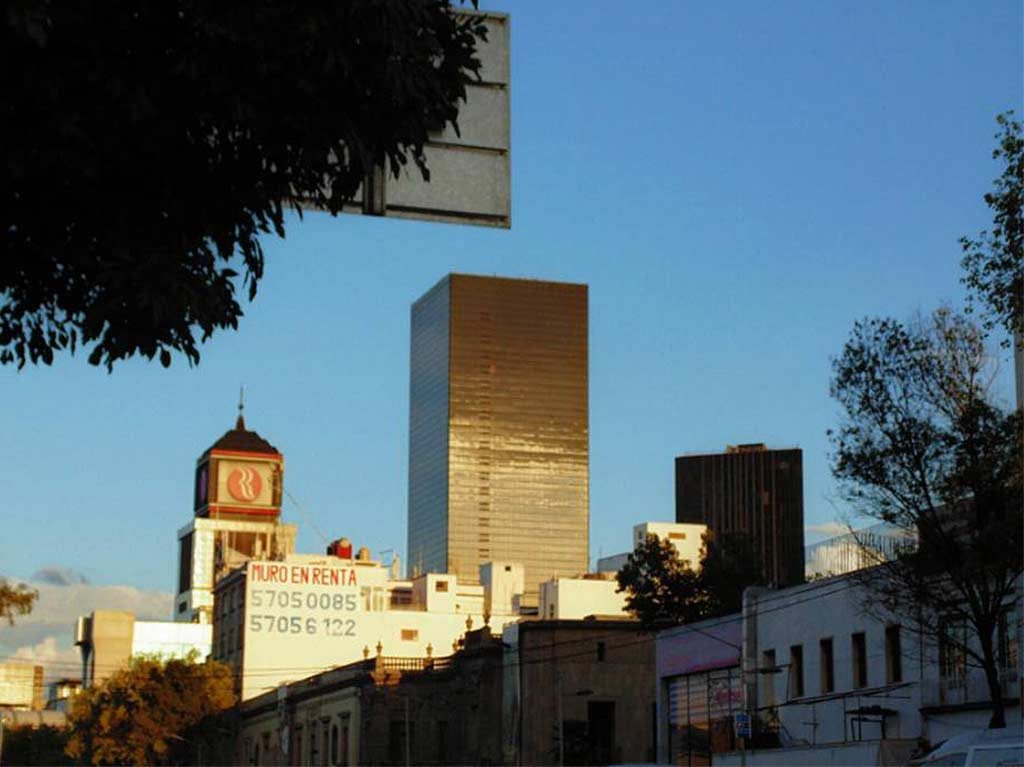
[656, 571, 1022, 767]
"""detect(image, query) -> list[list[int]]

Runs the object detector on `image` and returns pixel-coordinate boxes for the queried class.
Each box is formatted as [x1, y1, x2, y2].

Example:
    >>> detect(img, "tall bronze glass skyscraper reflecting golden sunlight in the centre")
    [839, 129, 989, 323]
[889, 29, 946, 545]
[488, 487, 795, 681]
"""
[409, 274, 590, 596]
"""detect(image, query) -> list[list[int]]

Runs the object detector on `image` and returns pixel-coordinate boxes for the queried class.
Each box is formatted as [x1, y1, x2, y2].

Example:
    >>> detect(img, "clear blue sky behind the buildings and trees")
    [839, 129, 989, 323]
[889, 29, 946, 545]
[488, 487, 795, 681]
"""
[0, 0, 1024, 671]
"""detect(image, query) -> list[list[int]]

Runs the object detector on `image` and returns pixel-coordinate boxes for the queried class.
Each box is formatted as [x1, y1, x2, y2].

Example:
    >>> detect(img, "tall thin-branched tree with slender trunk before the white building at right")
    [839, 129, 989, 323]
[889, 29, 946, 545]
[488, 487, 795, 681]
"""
[829, 309, 1024, 726]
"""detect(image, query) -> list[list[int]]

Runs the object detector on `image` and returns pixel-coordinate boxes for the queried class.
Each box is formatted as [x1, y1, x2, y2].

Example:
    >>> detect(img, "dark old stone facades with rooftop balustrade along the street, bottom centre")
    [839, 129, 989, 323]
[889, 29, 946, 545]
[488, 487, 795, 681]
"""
[237, 621, 654, 765]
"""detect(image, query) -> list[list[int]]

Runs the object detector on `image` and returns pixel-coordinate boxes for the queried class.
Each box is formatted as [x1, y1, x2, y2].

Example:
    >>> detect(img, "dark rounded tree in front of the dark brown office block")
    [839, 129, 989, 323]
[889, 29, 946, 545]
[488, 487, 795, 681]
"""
[616, 534, 762, 629]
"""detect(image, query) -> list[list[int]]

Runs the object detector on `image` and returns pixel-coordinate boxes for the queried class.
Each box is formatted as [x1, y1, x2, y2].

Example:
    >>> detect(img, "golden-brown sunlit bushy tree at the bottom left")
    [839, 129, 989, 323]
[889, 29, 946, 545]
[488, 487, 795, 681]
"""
[67, 656, 236, 765]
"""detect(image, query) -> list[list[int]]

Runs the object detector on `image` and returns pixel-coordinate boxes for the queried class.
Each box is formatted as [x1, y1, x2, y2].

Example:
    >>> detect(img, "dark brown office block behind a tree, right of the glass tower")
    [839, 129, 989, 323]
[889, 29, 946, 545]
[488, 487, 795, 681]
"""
[676, 443, 804, 586]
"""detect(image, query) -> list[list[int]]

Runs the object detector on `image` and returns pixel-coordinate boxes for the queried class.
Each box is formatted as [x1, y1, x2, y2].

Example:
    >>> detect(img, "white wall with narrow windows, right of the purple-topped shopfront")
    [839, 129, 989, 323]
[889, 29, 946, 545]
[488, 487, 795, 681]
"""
[716, 572, 1021, 765]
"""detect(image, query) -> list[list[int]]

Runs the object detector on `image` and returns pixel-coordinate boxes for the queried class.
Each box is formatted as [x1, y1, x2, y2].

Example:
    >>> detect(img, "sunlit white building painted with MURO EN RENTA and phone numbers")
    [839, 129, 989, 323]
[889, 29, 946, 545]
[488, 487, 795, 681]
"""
[213, 554, 524, 700]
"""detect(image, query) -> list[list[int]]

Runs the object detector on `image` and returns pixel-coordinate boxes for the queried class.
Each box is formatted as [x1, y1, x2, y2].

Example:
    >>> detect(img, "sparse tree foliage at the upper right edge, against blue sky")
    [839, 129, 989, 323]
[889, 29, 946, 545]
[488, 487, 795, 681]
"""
[961, 112, 1024, 342]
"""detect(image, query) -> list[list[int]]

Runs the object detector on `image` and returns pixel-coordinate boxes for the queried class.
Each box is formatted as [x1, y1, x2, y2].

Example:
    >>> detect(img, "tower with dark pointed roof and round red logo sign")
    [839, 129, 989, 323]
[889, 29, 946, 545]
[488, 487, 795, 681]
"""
[174, 402, 296, 623]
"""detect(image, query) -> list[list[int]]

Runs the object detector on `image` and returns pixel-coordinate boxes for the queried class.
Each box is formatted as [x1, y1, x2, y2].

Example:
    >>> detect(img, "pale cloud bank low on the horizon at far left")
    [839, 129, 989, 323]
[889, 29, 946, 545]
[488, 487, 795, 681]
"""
[0, 568, 174, 679]
